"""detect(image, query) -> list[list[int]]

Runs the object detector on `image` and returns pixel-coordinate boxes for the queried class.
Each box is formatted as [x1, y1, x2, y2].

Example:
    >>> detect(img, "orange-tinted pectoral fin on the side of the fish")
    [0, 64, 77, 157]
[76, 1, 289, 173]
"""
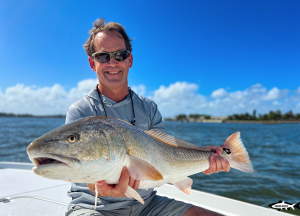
[127, 155, 164, 181]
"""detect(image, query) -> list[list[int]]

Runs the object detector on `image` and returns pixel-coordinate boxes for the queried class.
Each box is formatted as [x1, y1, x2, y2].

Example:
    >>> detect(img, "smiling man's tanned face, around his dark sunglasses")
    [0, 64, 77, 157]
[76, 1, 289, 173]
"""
[89, 31, 133, 89]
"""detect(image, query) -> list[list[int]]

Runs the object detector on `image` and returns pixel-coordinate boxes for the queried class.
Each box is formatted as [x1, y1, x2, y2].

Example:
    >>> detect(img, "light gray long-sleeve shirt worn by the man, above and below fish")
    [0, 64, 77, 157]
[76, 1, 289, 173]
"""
[66, 88, 164, 210]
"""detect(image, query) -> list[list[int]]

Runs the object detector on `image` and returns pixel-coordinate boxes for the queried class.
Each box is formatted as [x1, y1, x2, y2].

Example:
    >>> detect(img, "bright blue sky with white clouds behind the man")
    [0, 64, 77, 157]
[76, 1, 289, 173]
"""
[0, 0, 300, 115]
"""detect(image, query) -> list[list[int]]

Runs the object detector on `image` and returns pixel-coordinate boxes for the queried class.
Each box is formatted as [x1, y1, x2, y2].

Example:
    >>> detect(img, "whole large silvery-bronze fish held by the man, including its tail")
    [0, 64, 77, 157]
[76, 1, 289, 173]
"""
[27, 117, 253, 202]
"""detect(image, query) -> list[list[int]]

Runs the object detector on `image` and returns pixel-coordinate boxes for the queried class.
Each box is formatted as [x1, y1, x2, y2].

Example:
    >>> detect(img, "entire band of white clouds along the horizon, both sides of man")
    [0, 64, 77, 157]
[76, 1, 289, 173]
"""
[0, 79, 300, 117]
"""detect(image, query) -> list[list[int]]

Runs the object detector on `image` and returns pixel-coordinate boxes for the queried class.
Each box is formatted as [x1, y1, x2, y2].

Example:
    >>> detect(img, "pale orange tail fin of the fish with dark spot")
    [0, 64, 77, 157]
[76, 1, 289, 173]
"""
[221, 132, 254, 173]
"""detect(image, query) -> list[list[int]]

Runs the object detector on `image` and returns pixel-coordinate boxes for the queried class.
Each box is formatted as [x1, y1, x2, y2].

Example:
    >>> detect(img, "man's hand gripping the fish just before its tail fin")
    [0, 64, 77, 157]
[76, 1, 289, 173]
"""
[203, 146, 230, 175]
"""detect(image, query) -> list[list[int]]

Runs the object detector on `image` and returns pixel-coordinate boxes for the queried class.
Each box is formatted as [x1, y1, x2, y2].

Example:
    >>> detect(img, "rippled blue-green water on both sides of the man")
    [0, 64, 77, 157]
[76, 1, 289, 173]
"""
[0, 118, 300, 215]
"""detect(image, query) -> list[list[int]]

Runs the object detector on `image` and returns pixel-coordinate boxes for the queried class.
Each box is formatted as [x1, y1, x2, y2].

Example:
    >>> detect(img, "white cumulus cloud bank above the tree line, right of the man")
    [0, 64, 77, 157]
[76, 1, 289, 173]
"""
[151, 82, 300, 117]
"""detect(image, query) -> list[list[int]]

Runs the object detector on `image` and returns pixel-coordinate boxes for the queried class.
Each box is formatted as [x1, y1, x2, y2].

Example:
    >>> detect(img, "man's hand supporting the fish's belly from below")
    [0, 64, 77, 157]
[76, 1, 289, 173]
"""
[88, 167, 140, 197]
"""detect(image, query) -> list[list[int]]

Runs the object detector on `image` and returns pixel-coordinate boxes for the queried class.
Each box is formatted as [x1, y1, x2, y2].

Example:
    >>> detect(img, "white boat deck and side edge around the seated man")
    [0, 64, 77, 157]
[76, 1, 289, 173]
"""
[0, 162, 287, 216]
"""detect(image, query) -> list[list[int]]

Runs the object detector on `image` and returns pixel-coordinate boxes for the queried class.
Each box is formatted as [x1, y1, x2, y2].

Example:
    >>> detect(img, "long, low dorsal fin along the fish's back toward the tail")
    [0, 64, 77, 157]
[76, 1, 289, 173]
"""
[145, 129, 211, 151]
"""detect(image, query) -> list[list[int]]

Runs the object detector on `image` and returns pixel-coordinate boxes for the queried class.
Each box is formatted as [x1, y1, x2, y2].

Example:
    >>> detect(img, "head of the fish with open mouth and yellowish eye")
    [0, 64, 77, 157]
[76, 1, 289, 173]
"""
[27, 118, 123, 182]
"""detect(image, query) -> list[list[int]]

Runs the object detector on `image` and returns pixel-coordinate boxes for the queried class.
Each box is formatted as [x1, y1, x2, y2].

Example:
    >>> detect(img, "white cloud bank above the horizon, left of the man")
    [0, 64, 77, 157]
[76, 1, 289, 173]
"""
[0, 79, 97, 115]
